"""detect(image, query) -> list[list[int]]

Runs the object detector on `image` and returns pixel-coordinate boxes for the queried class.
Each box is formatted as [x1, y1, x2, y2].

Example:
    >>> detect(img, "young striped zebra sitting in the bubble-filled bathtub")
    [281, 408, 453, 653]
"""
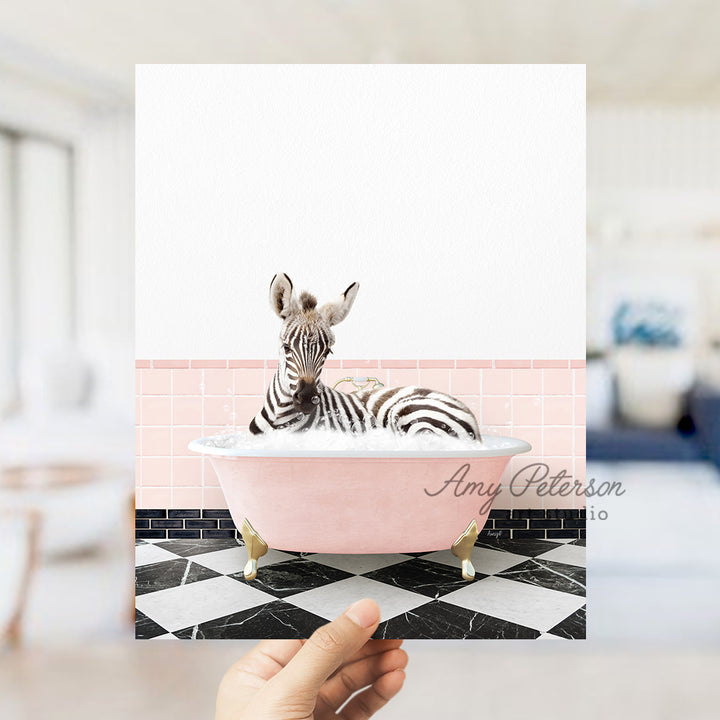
[250, 273, 481, 440]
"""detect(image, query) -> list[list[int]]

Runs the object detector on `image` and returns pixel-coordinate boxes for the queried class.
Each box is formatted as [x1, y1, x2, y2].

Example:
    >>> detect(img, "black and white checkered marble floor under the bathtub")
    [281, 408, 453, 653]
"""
[135, 538, 585, 640]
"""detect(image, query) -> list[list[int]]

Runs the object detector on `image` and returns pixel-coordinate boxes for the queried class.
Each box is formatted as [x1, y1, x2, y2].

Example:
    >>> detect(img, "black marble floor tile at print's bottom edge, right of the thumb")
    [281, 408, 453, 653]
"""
[373, 600, 540, 640]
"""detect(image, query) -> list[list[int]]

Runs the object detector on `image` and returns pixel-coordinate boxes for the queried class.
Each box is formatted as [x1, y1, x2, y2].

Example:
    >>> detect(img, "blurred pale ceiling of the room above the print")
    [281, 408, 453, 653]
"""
[0, 0, 720, 103]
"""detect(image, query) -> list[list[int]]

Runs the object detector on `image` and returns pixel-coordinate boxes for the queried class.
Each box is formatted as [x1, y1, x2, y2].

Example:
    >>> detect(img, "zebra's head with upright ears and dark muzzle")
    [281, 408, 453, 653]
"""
[270, 273, 360, 415]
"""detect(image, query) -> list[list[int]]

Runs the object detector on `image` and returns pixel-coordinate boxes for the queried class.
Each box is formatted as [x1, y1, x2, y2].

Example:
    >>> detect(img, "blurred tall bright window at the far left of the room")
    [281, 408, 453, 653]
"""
[0, 128, 76, 414]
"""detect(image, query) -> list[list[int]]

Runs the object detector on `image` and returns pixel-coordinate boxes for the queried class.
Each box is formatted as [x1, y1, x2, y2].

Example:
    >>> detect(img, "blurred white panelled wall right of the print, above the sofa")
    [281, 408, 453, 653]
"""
[588, 105, 720, 239]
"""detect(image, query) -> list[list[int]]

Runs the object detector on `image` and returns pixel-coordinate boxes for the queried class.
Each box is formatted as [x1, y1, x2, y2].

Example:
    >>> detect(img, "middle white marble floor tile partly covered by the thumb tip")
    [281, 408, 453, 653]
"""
[287, 576, 429, 620]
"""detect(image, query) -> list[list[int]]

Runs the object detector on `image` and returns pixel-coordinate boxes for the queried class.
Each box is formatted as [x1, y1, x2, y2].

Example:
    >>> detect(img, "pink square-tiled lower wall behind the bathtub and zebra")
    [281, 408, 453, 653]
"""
[135, 359, 585, 509]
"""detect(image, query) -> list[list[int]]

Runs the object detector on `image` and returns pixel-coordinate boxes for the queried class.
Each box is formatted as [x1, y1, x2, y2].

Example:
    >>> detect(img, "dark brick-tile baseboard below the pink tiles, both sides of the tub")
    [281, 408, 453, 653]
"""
[135, 510, 585, 540]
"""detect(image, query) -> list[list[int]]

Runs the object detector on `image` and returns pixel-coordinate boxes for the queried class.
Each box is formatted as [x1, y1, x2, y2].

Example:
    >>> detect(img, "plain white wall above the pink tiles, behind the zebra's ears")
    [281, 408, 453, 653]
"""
[136, 65, 585, 358]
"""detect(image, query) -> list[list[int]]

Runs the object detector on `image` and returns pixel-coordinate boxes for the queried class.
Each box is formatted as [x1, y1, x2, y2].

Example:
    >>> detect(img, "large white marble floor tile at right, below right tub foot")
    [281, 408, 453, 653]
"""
[443, 577, 585, 632]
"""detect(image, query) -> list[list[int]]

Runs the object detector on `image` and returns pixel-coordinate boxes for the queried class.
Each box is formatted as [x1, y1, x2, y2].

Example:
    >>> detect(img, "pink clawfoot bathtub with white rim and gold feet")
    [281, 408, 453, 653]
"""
[190, 436, 531, 579]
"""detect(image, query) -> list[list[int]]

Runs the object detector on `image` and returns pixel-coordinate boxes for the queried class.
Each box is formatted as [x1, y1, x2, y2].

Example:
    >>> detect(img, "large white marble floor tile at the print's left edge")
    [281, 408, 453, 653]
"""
[135, 577, 275, 632]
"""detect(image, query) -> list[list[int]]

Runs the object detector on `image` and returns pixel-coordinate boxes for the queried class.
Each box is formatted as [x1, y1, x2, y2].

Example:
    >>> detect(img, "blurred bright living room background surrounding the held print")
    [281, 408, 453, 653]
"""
[0, 0, 720, 718]
